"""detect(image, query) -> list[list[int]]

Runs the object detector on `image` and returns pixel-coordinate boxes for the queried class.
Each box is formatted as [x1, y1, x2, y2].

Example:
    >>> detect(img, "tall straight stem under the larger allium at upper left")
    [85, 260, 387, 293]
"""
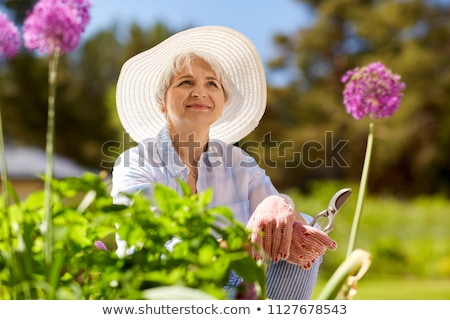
[44, 47, 60, 267]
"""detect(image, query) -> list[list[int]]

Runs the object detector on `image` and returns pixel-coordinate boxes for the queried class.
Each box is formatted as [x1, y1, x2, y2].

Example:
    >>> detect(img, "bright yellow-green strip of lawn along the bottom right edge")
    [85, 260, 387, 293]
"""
[311, 277, 450, 300]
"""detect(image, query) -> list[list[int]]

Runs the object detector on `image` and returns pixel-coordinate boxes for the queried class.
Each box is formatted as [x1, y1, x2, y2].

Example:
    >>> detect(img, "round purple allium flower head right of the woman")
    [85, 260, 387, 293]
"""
[341, 62, 406, 120]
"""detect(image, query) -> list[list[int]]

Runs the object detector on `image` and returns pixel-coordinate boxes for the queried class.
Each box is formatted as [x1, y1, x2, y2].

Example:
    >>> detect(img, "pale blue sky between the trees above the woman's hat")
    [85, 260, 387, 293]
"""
[85, 0, 313, 82]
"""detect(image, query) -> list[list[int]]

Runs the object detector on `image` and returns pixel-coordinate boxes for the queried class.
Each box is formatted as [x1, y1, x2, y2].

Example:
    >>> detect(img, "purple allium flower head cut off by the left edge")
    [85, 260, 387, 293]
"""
[0, 12, 20, 60]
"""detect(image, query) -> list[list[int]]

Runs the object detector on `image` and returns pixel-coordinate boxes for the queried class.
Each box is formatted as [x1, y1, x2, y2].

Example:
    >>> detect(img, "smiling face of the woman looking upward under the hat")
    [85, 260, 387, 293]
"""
[161, 59, 226, 131]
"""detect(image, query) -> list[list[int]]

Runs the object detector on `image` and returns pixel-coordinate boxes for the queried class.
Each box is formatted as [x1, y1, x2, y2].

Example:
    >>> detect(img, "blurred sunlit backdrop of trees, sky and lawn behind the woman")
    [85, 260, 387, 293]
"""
[0, 0, 450, 299]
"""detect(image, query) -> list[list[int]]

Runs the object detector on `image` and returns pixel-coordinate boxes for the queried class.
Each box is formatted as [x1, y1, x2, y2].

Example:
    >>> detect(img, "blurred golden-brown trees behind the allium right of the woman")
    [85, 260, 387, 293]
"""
[252, 0, 450, 195]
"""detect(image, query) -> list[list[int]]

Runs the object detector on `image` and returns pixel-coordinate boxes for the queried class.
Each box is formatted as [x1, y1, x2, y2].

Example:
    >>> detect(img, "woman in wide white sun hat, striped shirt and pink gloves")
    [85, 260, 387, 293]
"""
[111, 26, 336, 299]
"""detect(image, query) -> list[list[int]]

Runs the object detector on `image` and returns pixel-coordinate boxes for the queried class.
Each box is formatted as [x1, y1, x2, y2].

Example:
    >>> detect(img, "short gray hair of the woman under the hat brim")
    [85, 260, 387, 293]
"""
[155, 51, 231, 105]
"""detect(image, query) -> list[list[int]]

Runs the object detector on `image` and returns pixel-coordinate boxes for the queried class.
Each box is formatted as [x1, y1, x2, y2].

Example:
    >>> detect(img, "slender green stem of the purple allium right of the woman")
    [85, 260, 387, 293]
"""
[347, 118, 374, 257]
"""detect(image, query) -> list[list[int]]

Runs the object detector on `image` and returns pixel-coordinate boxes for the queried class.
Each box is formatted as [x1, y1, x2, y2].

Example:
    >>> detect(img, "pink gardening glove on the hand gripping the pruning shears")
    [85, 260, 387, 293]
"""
[284, 222, 337, 269]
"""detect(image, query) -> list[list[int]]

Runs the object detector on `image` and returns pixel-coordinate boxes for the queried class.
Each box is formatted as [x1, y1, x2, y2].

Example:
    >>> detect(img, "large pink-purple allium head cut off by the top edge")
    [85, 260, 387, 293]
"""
[23, 0, 91, 54]
